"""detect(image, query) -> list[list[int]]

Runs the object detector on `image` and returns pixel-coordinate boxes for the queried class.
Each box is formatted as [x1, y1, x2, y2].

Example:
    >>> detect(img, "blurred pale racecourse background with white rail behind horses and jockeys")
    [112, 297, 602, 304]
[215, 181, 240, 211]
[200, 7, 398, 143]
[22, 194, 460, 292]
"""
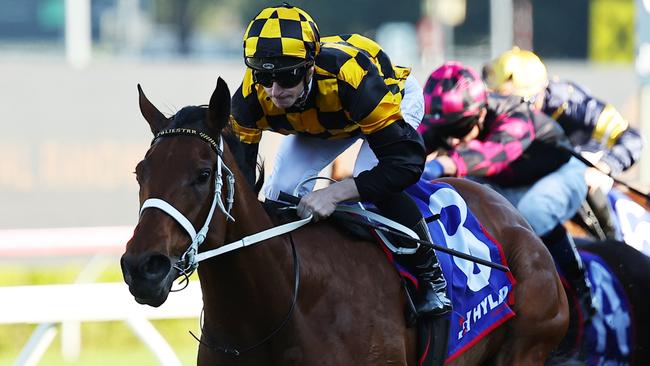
[0, 0, 650, 365]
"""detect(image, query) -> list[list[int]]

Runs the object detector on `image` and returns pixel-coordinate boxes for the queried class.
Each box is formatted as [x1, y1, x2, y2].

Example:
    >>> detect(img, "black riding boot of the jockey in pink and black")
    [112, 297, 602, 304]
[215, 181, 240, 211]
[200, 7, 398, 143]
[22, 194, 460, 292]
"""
[542, 225, 596, 321]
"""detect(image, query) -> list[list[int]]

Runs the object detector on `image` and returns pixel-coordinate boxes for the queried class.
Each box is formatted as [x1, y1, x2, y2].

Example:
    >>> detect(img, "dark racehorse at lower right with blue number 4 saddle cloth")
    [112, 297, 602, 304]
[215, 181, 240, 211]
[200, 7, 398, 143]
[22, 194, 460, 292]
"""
[555, 238, 650, 365]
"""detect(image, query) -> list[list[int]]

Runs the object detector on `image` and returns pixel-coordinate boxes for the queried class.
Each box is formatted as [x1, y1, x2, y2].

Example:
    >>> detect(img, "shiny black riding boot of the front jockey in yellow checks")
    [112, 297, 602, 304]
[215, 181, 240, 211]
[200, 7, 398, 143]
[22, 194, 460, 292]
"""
[409, 219, 451, 316]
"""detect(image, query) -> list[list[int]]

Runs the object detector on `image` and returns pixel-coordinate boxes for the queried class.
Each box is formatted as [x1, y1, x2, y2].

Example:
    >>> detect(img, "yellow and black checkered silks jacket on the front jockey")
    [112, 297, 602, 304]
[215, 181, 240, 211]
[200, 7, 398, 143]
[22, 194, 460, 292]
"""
[232, 34, 411, 143]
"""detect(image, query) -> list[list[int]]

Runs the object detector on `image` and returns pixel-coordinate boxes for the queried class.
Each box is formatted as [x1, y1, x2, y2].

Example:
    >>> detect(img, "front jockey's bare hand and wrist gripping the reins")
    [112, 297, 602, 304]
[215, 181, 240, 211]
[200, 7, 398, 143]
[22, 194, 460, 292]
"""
[296, 179, 359, 221]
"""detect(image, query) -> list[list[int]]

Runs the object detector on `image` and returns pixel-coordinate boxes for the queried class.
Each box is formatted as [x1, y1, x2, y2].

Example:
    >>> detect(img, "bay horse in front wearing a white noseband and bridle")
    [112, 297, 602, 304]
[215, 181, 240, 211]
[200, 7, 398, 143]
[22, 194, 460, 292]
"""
[121, 78, 569, 365]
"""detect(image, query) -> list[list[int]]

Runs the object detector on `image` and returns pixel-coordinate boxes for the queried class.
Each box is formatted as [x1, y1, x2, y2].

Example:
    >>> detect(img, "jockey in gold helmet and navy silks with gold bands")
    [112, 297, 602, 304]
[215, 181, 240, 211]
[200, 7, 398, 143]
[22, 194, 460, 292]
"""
[483, 47, 643, 238]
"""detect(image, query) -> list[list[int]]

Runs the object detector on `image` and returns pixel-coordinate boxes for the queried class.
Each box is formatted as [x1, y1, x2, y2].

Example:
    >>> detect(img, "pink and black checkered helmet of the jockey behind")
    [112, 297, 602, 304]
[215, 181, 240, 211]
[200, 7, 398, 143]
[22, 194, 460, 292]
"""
[418, 61, 487, 137]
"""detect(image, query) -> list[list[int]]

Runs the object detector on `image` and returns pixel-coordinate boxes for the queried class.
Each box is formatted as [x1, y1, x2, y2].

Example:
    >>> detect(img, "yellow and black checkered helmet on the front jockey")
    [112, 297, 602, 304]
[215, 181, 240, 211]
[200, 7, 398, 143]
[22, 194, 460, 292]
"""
[244, 3, 320, 71]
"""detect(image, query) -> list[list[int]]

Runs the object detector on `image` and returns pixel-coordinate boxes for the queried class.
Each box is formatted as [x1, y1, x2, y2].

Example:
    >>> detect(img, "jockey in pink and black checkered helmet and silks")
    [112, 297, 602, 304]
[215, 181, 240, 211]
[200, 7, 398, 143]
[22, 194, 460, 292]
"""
[418, 62, 593, 316]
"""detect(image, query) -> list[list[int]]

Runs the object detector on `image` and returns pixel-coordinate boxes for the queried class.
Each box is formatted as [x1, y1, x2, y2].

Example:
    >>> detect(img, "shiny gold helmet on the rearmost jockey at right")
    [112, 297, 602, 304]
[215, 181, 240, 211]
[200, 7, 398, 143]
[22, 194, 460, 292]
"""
[483, 47, 548, 98]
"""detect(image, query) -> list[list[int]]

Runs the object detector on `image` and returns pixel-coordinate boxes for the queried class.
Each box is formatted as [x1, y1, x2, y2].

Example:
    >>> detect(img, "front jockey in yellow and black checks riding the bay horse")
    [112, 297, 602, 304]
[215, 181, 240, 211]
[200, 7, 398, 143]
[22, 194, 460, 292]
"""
[232, 3, 451, 315]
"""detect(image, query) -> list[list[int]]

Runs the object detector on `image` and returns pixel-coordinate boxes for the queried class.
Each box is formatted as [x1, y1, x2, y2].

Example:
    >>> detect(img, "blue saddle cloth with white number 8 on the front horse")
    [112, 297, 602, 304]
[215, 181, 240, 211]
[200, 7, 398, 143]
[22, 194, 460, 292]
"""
[398, 180, 515, 362]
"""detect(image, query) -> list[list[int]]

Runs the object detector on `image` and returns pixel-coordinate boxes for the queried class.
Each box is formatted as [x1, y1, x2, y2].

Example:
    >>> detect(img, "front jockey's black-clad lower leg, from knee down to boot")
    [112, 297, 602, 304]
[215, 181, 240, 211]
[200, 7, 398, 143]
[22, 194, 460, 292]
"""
[375, 192, 451, 316]
